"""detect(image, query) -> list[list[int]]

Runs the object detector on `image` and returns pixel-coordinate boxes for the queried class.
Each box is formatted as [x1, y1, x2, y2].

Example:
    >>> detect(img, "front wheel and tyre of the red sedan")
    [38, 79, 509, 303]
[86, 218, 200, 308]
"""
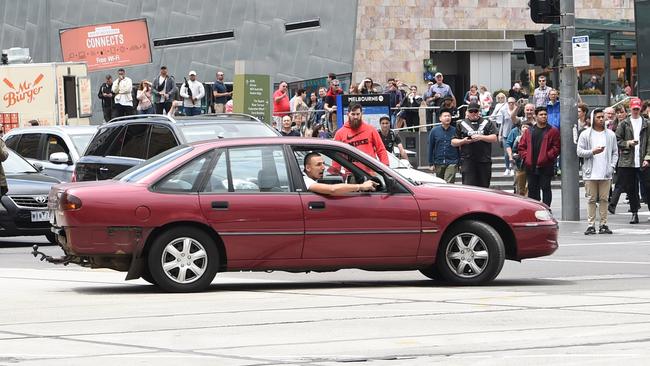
[432, 221, 505, 285]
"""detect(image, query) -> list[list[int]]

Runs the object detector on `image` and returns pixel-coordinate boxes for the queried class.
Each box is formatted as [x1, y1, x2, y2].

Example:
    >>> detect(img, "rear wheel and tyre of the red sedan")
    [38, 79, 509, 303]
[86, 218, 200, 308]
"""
[145, 227, 219, 292]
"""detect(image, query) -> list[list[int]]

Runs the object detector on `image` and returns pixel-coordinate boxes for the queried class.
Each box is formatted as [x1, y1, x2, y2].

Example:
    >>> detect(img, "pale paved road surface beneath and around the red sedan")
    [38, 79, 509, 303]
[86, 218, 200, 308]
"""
[0, 187, 650, 366]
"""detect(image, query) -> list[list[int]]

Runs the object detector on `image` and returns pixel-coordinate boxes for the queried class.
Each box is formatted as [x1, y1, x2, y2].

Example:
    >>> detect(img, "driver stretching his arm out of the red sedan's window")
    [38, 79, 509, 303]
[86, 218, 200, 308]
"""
[303, 152, 377, 196]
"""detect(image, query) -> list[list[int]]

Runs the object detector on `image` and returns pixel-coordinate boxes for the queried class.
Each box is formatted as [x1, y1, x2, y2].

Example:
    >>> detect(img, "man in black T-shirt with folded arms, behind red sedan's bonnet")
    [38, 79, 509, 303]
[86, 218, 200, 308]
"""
[451, 103, 497, 188]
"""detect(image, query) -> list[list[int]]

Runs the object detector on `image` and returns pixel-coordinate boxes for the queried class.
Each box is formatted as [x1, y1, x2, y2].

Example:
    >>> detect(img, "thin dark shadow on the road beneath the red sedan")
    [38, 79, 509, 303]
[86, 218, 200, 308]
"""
[73, 279, 574, 295]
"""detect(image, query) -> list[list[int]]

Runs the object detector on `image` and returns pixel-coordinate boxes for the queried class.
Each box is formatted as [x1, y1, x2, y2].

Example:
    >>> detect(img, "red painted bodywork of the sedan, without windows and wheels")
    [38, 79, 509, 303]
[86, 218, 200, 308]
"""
[50, 137, 558, 278]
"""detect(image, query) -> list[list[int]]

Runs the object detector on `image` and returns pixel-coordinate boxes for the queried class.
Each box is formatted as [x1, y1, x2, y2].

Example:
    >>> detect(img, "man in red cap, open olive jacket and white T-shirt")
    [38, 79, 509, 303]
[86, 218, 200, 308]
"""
[608, 98, 650, 224]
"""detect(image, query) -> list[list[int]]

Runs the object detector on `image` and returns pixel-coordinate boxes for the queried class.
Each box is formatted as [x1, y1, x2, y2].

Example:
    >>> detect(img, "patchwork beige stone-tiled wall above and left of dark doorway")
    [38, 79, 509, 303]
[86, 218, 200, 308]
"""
[353, 0, 634, 90]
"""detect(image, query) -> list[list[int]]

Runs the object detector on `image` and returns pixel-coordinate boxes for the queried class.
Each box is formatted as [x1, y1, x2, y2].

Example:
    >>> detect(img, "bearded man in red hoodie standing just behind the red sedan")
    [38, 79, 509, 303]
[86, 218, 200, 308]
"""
[334, 103, 388, 165]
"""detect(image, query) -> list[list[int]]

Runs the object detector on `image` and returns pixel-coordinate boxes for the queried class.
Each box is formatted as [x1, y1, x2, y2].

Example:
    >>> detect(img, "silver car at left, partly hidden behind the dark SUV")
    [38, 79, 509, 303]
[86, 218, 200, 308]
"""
[2, 126, 97, 182]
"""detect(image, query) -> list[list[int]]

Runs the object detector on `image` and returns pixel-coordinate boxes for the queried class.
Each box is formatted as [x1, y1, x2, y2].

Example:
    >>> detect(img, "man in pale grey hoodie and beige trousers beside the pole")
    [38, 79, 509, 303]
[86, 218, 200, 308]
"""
[577, 109, 618, 235]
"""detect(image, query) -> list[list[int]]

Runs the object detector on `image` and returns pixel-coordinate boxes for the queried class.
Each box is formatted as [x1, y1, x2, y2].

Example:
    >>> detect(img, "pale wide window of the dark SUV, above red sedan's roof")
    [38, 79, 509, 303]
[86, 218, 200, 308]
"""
[179, 122, 278, 143]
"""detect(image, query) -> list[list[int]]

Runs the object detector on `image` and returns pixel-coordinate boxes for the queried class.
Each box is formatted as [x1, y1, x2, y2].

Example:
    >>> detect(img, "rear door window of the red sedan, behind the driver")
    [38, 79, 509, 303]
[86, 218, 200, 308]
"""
[205, 146, 291, 193]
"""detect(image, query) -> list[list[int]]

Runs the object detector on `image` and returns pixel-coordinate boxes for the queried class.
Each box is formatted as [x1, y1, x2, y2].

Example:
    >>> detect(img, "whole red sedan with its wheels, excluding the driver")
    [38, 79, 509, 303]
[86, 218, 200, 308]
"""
[41, 137, 558, 292]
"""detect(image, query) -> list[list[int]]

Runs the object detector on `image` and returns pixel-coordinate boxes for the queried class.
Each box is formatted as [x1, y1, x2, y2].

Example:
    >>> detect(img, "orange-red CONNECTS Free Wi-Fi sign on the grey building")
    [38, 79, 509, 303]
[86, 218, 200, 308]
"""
[59, 19, 151, 71]
